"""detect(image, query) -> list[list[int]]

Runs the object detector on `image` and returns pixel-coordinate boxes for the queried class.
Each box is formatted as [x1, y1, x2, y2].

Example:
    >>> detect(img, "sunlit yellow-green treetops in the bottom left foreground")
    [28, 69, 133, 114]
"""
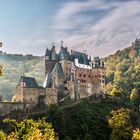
[3, 119, 58, 140]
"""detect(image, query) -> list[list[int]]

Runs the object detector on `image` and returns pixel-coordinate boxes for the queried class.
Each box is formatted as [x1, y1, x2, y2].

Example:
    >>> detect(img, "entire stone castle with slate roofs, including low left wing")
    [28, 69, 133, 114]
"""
[16, 42, 105, 106]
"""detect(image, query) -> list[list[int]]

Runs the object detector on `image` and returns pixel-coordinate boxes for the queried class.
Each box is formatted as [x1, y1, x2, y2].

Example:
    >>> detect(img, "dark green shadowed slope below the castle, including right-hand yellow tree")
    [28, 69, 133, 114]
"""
[0, 98, 140, 140]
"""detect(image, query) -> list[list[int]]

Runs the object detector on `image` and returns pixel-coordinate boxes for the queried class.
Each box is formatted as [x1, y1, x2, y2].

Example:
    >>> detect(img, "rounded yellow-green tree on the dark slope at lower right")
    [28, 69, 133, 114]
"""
[108, 108, 132, 140]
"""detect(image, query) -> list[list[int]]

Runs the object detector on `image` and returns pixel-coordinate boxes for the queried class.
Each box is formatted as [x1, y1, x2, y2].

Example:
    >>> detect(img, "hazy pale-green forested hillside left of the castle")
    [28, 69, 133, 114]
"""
[0, 52, 44, 100]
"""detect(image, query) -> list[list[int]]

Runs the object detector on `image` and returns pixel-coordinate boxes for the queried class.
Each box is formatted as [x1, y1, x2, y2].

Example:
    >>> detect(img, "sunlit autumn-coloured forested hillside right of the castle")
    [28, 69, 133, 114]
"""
[104, 39, 140, 98]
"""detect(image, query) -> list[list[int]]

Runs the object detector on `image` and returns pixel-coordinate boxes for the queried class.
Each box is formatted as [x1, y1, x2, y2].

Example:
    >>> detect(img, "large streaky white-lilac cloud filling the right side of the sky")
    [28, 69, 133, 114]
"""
[54, 0, 140, 56]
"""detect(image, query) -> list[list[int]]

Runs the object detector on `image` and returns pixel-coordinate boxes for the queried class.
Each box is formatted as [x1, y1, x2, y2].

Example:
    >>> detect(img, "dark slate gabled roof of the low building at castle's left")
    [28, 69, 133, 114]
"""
[20, 76, 38, 87]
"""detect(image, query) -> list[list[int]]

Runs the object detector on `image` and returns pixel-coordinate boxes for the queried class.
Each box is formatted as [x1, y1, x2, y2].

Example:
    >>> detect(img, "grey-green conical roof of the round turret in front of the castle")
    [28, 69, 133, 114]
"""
[52, 62, 64, 76]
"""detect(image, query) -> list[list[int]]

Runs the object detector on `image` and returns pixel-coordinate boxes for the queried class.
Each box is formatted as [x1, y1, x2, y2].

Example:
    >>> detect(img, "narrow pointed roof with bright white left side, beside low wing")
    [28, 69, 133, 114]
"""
[43, 72, 52, 88]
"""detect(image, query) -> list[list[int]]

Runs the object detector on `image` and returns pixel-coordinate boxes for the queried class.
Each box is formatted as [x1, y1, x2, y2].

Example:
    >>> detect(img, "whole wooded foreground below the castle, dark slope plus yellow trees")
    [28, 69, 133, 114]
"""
[0, 99, 140, 140]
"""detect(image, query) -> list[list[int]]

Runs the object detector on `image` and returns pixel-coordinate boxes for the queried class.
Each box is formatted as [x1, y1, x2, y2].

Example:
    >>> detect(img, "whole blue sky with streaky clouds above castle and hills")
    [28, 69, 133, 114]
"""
[0, 0, 140, 57]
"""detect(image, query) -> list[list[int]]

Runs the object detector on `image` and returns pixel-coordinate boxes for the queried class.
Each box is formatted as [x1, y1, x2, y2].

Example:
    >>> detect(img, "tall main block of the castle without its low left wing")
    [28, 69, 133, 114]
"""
[45, 44, 105, 100]
